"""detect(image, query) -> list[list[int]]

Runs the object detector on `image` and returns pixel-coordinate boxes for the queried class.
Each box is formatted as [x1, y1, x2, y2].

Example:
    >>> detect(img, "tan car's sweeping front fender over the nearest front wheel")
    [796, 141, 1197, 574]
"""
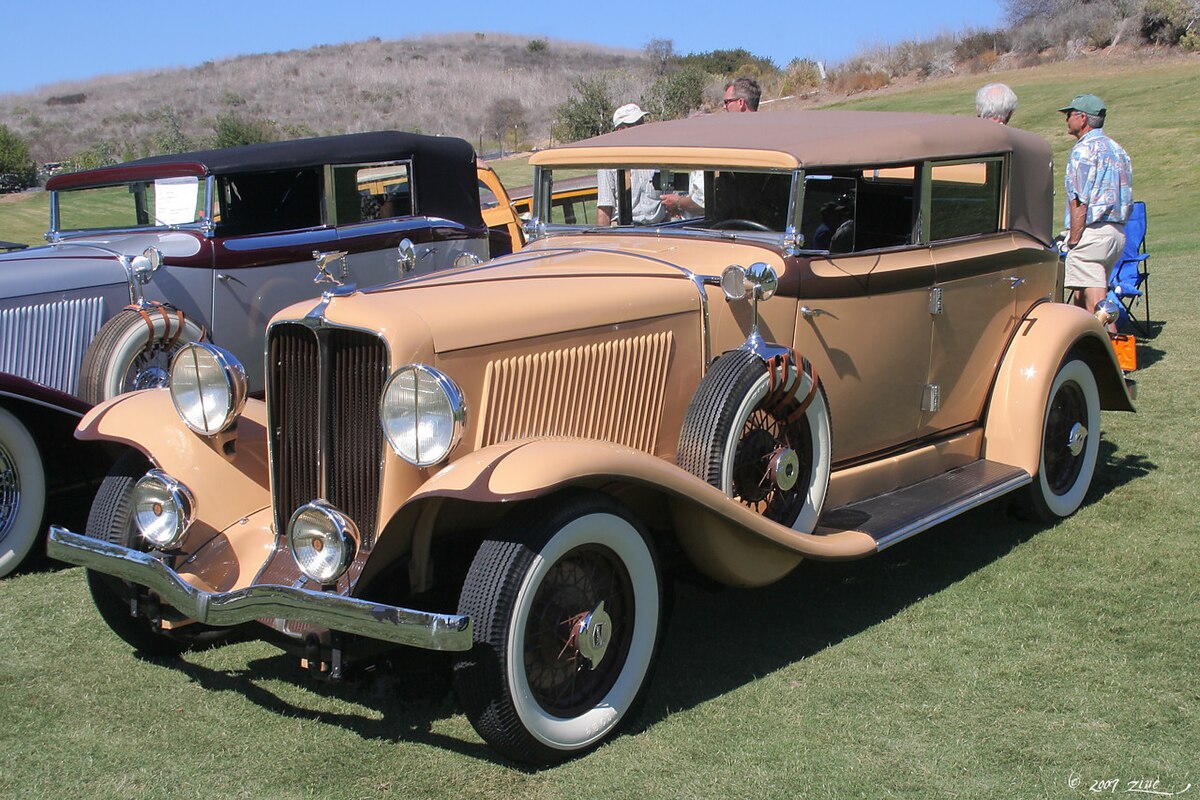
[407, 438, 876, 585]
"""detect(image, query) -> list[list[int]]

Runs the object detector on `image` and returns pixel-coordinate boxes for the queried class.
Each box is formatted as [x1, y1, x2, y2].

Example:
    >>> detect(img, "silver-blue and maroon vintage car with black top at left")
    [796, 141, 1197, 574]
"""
[0, 131, 488, 577]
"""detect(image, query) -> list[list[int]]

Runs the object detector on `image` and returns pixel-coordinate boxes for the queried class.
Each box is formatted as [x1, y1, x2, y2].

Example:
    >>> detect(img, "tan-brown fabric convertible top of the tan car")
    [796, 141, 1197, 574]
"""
[529, 110, 1052, 241]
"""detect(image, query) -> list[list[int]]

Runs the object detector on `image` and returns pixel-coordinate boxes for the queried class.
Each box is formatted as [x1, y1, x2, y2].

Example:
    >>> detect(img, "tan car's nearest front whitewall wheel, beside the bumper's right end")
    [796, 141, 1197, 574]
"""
[455, 489, 662, 765]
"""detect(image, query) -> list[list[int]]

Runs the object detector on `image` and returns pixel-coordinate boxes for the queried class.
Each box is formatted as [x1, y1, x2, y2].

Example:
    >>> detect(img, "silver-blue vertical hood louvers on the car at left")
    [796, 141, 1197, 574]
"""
[0, 297, 104, 395]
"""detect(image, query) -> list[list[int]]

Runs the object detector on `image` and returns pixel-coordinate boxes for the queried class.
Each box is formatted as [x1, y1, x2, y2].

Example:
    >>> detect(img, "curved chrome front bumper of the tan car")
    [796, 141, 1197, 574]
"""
[46, 525, 472, 650]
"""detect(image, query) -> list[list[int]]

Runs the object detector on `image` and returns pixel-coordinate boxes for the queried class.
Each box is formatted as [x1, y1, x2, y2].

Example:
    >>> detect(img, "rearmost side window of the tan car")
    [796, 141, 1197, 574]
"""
[929, 158, 1003, 241]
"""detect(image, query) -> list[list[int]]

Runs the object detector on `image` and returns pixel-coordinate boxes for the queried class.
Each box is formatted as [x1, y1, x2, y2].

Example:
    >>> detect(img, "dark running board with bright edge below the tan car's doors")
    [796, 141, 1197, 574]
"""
[816, 459, 1033, 551]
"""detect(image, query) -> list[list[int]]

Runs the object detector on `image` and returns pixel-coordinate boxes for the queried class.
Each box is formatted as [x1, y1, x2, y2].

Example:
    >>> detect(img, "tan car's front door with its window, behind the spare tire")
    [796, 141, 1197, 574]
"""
[796, 167, 935, 462]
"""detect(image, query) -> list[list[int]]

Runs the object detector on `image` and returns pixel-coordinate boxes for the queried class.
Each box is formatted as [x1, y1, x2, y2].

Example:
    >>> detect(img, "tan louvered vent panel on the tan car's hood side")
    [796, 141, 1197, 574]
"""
[478, 332, 672, 452]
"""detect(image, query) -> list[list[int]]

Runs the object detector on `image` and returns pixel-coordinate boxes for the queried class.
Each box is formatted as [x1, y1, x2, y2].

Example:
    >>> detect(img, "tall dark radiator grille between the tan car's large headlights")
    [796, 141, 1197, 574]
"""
[268, 324, 388, 549]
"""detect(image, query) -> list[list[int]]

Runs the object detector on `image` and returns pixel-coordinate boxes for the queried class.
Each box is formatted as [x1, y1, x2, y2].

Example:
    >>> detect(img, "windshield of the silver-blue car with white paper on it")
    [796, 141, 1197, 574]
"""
[55, 176, 205, 230]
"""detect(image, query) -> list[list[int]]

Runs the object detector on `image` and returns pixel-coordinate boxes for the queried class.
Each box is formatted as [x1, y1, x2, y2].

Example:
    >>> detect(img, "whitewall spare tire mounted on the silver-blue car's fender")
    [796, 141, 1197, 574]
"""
[79, 303, 204, 403]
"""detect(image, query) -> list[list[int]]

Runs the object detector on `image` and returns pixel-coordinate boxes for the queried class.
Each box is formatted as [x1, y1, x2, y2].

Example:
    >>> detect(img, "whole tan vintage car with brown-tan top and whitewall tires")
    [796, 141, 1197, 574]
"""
[49, 112, 1133, 764]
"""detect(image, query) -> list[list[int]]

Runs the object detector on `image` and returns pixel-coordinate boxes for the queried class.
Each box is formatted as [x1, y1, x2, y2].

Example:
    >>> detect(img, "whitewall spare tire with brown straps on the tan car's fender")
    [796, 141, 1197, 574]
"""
[677, 350, 832, 533]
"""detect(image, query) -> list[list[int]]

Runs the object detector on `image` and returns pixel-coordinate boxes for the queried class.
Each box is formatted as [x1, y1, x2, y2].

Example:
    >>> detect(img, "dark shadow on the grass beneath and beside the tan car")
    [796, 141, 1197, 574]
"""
[136, 440, 1156, 771]
